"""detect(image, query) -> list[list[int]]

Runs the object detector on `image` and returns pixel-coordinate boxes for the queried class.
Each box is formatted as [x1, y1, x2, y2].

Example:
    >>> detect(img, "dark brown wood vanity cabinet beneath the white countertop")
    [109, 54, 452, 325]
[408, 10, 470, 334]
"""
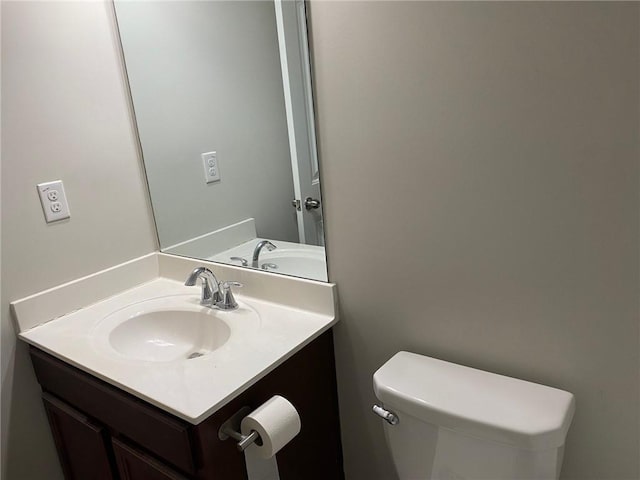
[31, 331, 344, 480]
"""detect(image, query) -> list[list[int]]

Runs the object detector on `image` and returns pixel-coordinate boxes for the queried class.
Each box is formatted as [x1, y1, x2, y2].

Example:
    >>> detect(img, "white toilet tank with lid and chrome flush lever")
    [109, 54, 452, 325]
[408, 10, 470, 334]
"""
[373, 352, 575, 480]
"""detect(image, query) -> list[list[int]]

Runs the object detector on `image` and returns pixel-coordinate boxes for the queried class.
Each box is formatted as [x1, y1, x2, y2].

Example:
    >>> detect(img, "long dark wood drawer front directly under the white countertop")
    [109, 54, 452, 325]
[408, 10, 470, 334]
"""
[31, 347, 196, 473]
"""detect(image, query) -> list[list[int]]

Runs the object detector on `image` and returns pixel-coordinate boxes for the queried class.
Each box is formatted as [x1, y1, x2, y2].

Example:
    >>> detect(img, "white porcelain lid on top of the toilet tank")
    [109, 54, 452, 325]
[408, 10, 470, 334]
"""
[373, 352, 575, 450]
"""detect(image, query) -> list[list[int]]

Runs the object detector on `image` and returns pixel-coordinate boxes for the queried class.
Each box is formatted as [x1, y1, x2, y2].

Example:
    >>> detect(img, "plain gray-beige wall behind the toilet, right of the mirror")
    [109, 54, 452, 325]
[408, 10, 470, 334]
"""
[311, 2, 640, 480]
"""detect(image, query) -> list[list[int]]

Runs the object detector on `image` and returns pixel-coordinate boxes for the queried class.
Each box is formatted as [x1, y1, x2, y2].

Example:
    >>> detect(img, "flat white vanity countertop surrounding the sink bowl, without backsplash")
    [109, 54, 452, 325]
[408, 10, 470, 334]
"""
[19, 255, 337, 424]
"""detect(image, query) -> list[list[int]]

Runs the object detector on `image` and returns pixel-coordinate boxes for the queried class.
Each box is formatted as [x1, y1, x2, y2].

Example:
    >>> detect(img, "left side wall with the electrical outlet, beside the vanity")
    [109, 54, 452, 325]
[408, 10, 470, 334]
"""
[1, 2, 157, 480]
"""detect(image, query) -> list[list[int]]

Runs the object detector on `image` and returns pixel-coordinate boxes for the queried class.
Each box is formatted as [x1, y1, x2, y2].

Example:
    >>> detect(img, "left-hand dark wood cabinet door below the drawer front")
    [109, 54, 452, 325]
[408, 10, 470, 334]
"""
[42, 393, 114, 480]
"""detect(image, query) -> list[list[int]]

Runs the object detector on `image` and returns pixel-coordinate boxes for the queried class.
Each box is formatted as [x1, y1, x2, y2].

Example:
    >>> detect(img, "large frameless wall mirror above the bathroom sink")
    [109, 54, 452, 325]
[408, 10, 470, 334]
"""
[114, 0, 327, 281]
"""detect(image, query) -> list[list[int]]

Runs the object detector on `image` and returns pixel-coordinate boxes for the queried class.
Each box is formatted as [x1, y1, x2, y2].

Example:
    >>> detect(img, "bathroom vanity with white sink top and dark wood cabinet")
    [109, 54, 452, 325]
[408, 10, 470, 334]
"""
[12, 254, 343, 480]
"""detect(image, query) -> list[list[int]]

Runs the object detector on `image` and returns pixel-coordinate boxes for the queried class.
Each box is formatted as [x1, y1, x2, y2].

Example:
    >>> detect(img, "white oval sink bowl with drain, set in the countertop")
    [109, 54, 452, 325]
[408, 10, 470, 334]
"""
[109, 310, 231, 362]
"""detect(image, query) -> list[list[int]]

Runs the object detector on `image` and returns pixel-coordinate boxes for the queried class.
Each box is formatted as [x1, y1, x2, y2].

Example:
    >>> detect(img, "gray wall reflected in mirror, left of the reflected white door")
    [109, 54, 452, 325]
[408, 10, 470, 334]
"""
[117, 0, 298, 251]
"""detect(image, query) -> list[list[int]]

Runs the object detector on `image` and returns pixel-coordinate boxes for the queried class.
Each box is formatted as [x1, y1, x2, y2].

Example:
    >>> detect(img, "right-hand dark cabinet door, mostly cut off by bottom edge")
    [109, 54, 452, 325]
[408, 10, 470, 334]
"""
[112, 438, 187, 480]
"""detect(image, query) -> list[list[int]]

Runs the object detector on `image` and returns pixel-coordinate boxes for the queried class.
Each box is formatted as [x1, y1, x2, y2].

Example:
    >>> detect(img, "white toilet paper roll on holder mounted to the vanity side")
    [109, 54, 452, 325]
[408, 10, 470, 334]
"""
[240, 395, 301, 458]
